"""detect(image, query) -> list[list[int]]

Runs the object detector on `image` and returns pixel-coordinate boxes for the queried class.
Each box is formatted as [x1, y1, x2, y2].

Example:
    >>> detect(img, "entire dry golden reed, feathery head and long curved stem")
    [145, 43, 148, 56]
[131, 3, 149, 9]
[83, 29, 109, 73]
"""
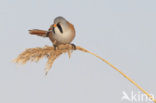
[14, 41, 156, 103]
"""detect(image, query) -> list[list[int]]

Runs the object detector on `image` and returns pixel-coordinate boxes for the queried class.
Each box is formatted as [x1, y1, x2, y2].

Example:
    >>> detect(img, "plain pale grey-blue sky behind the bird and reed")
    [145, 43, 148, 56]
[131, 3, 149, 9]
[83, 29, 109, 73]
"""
[0, 0, 156, 103]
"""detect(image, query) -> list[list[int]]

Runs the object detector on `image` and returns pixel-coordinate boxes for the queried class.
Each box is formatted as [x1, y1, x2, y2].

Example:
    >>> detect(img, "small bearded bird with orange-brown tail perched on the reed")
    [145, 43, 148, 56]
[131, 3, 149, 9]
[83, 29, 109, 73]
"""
[29, 16, 76, 50]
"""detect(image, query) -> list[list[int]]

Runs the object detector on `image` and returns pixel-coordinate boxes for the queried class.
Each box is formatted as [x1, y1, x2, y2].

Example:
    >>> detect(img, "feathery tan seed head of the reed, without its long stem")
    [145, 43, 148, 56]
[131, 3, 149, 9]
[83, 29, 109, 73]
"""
[14, 44, 87, 74]
